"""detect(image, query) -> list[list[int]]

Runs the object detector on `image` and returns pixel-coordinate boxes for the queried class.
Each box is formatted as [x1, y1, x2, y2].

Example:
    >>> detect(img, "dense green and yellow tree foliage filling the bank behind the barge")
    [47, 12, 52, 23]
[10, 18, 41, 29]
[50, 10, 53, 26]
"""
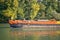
[0, 0, 60, 22]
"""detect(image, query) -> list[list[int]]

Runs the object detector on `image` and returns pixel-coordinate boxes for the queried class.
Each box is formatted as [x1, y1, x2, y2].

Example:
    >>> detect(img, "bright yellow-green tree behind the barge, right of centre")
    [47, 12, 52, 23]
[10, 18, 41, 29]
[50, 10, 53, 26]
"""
[30, 0, 40, 20]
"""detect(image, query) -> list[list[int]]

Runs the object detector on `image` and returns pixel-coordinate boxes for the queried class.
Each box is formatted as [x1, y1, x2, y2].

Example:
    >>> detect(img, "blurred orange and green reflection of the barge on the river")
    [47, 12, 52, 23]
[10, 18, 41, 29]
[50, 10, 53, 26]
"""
[10, 28, 60, 40]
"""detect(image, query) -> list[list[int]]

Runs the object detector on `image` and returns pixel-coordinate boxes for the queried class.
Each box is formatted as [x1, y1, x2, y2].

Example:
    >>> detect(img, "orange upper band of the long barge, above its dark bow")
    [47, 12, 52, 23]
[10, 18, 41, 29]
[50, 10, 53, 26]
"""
[9, 20, 60, 24]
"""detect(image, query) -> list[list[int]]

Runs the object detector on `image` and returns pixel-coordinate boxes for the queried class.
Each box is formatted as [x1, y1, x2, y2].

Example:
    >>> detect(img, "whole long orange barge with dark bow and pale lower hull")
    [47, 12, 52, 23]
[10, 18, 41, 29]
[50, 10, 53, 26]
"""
[9, 20, 60, 28]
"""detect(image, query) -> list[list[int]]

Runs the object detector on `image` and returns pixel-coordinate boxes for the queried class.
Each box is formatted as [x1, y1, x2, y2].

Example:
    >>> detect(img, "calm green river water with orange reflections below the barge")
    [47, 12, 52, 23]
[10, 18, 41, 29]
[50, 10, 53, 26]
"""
[0, 24, 60, 40]
